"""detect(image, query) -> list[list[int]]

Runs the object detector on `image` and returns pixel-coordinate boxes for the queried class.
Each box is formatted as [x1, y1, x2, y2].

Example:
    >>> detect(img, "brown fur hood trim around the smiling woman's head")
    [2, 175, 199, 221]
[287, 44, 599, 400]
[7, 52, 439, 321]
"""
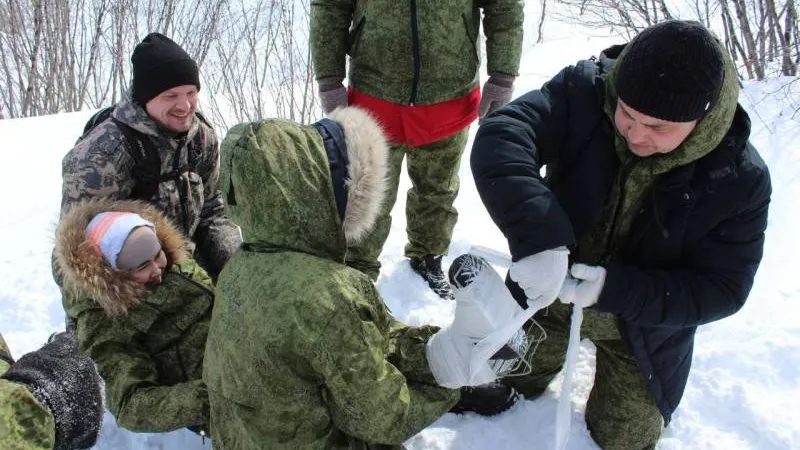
[55, 200, 189, 317]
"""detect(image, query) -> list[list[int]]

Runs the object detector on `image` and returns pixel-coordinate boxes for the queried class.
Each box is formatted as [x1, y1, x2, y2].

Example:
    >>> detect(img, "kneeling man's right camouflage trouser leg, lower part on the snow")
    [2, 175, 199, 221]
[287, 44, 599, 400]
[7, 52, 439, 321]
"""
[586, 340, 664, 450]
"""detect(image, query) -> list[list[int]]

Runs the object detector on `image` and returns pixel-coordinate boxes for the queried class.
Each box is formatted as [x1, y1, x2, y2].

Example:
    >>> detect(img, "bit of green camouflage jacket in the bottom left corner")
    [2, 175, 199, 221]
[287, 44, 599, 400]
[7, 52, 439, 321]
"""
[0, 335, 56, 450]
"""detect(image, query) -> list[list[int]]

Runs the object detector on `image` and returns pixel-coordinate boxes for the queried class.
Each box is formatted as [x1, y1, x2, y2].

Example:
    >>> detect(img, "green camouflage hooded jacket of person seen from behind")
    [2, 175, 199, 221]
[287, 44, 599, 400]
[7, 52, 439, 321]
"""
[203, 110, 459, 450]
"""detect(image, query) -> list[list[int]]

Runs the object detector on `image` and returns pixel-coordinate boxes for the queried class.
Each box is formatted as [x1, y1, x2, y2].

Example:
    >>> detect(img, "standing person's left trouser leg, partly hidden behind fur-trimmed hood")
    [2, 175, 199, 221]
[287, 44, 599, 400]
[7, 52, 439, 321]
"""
[347, 145, 408, 280]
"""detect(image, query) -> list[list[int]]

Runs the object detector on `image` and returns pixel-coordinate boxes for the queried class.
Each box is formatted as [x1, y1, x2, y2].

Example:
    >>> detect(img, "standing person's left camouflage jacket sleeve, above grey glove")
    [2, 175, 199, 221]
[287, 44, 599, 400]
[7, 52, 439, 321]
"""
[310, 0, 355, 80]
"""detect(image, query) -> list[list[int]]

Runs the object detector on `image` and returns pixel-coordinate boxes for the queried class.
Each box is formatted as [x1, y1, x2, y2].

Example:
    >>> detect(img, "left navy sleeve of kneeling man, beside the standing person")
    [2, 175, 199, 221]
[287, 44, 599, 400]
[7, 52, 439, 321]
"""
[470, 66, 575, 261]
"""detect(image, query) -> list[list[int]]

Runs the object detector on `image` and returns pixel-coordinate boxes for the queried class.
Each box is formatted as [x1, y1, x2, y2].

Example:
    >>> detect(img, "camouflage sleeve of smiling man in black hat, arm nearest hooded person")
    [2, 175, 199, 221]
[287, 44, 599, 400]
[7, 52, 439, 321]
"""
[192, 127, 242, 277]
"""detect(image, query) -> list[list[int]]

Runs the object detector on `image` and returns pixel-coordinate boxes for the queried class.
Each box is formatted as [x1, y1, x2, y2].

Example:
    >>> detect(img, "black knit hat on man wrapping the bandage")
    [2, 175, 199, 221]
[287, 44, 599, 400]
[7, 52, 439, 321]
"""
[614, 20, 725, 122]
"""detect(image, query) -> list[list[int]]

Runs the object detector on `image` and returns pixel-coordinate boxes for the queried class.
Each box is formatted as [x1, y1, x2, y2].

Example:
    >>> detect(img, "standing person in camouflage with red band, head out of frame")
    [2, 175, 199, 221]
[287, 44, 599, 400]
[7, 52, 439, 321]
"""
[310, 0, 523, 298]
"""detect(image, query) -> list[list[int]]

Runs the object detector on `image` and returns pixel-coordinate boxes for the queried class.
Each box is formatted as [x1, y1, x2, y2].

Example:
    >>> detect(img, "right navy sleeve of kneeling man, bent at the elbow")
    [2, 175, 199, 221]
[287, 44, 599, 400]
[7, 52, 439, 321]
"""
[595, 158, 772, 327]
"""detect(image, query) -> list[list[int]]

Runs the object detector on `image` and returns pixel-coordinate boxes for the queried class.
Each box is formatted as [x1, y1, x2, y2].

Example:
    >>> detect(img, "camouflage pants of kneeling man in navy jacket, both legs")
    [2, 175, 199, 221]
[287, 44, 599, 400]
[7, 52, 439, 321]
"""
[503, 302, 664, 450]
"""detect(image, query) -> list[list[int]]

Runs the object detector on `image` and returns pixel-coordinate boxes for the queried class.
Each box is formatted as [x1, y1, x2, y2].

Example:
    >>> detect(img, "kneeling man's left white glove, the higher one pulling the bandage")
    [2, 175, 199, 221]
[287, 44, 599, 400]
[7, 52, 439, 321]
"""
[508, 247, 569, 305]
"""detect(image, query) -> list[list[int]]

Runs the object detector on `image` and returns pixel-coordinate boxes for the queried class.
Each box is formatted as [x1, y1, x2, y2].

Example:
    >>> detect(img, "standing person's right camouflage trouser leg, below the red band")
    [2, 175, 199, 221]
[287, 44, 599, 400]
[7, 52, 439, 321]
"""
[405, 128, 469, 258]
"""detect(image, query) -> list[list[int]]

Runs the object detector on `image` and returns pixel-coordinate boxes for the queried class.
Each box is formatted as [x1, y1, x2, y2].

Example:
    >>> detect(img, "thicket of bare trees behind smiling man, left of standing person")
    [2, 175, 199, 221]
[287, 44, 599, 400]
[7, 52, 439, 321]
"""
[0, 0, 320, 126]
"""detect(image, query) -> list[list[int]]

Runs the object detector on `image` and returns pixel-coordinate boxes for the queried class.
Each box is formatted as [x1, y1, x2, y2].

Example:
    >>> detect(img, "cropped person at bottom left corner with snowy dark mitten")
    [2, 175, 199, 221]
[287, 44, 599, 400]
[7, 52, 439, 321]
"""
[0, 333, 103, 450]
